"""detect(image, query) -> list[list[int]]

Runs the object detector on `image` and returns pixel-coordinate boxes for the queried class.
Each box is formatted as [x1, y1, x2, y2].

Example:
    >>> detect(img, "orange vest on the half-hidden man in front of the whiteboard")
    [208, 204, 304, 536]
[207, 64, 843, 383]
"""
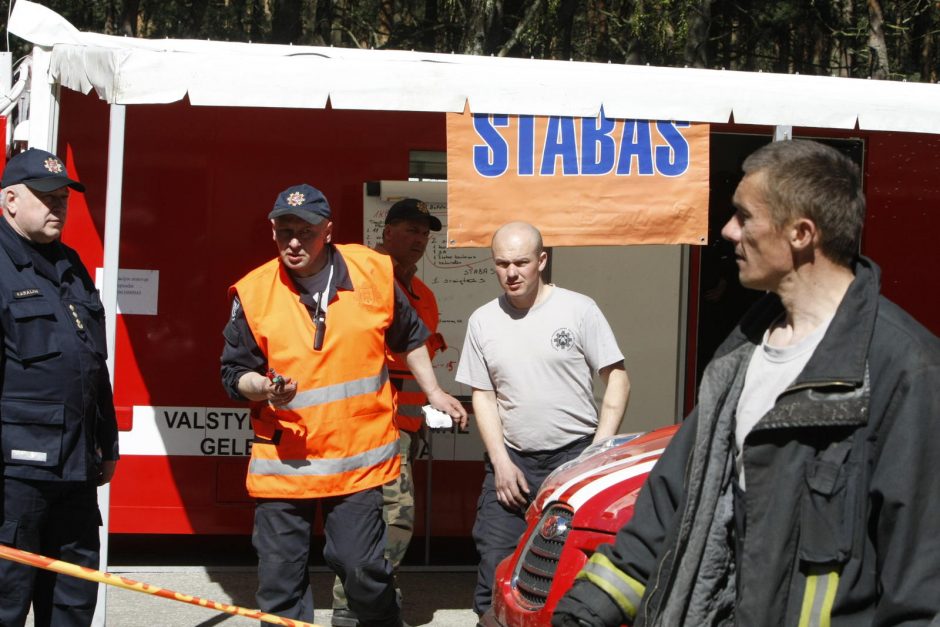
[388, 277, 447, 432]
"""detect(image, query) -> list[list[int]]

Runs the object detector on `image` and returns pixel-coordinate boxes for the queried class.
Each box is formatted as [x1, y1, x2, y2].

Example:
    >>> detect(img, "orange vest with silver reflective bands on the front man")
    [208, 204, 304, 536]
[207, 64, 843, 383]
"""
[232, 245, 400, 499]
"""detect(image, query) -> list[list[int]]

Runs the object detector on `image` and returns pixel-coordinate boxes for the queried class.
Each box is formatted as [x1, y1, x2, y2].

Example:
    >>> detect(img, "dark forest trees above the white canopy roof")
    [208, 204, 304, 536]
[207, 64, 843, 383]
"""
[7, 0, 940, 82]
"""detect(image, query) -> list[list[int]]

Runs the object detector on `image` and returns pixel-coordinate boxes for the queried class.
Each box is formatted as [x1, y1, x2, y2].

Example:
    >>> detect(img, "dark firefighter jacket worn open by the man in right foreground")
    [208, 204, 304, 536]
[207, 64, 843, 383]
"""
[559, 258, 940, 627]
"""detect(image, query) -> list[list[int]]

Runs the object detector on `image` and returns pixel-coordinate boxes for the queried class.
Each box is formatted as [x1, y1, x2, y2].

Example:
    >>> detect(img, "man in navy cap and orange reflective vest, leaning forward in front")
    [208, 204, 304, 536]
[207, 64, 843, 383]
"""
[222, 185, 467, 627]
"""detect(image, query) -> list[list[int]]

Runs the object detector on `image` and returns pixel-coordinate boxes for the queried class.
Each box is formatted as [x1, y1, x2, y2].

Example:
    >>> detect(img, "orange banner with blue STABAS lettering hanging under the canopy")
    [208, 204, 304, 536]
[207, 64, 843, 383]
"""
[447, 112, 709, 247]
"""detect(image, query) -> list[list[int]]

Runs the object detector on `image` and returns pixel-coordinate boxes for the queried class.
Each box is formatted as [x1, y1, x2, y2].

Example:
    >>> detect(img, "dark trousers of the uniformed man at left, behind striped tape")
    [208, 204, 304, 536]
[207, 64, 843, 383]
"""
[0, 477, 101, 627]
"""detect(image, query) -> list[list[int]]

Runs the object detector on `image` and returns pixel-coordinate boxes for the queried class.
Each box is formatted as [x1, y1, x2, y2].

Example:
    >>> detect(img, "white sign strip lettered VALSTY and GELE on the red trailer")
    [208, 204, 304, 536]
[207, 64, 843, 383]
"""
[120, 405, 254, 456]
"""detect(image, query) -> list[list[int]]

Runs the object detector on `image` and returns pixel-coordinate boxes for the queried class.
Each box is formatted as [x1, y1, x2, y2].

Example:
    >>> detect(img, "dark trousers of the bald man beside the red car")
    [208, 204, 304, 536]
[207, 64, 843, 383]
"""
[473, 436, 594, 615]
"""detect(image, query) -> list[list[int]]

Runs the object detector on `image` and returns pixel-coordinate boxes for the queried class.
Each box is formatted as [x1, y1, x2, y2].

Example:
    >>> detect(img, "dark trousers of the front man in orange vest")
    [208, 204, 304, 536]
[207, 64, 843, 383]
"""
[252, 486, 401, 627]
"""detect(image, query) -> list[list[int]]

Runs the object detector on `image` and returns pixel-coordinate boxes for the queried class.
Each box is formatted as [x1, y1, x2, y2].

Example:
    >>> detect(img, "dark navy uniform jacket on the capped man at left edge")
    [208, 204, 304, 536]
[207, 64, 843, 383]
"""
[0, 217, 118, 481]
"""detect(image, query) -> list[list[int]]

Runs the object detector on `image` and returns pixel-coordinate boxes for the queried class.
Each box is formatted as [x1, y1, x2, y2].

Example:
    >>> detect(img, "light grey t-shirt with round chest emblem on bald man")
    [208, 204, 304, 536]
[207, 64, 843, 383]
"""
[456, 287, 623, 451]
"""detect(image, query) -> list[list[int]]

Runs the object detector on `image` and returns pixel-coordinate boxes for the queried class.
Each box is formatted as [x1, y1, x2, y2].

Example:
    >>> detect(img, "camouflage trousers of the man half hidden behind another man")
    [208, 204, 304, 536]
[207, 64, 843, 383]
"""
[333, 431, 418, 610]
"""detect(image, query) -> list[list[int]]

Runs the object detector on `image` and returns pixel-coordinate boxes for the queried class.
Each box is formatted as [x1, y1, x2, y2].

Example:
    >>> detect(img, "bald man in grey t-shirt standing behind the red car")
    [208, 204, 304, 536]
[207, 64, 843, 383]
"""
[456, 222, 630, 615]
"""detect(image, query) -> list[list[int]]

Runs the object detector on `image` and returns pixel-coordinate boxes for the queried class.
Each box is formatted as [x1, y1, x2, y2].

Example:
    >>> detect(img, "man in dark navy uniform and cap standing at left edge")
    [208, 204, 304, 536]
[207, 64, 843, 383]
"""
[0, 149, 118, 627]
